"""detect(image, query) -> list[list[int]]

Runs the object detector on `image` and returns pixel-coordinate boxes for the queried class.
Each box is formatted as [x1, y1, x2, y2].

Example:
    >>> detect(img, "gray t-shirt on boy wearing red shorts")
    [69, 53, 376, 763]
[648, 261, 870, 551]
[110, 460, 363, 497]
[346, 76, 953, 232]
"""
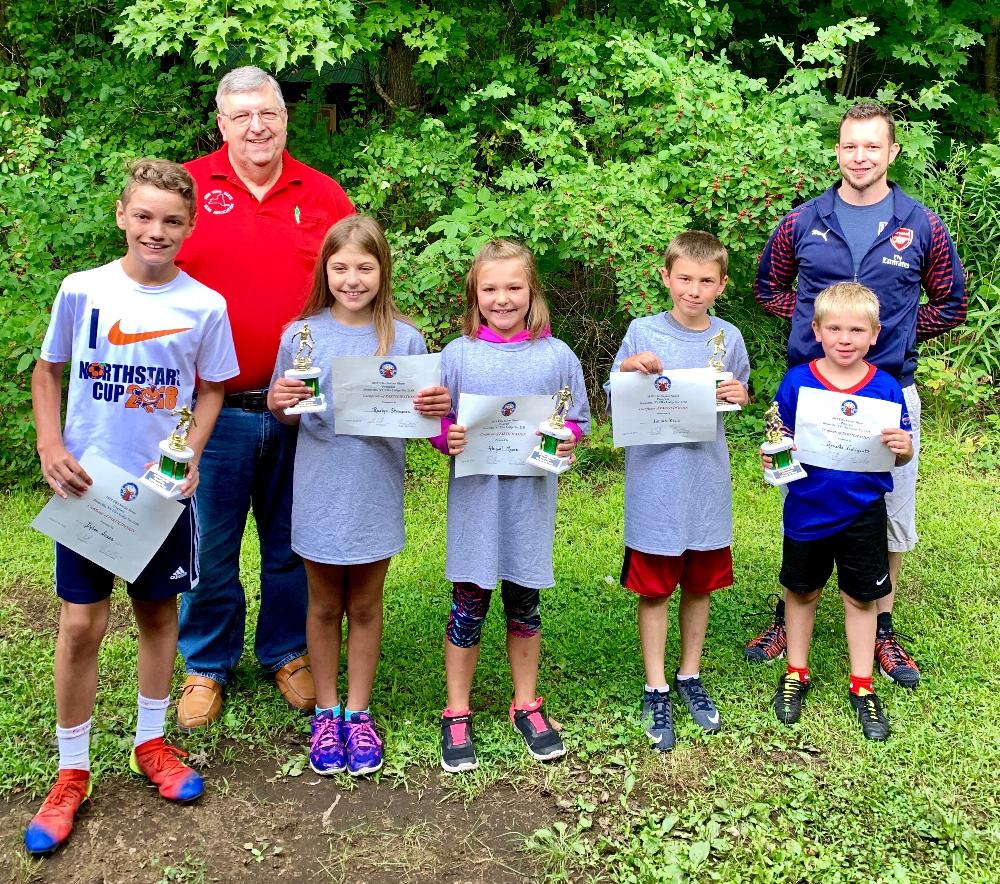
[604, 313, 750, 556]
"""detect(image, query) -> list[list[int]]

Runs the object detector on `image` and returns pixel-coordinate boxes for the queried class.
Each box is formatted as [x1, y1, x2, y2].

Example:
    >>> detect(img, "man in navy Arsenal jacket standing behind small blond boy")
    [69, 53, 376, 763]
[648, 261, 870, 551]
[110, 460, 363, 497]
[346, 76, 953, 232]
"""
[745, 103, 966, 688]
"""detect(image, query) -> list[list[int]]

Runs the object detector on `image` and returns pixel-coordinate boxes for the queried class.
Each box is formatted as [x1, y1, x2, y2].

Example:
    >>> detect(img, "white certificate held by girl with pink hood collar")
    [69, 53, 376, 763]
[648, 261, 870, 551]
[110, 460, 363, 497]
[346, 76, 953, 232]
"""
[455, 393, 554, 476]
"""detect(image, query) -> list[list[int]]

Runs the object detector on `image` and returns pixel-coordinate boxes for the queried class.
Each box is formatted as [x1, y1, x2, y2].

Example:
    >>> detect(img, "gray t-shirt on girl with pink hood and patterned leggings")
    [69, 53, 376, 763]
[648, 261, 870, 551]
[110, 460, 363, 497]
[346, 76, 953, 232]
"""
[441, 336, 590, 589]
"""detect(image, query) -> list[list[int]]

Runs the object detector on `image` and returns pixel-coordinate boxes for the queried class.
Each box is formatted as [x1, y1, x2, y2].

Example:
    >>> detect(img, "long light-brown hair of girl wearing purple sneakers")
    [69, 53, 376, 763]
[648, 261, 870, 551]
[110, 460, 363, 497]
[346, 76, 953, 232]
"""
[297, 215, 413, 356]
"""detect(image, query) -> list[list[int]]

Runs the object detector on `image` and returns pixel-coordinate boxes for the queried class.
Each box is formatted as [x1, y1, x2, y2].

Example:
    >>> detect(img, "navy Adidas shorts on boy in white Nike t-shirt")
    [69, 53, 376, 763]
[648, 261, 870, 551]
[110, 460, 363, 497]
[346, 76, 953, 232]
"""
[55, 499, 198, 605]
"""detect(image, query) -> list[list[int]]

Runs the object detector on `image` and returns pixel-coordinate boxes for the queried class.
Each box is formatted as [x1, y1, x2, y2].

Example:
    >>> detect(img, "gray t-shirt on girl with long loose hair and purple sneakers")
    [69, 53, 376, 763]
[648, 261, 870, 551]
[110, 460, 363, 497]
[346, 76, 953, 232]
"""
[271, 310, 427, 565]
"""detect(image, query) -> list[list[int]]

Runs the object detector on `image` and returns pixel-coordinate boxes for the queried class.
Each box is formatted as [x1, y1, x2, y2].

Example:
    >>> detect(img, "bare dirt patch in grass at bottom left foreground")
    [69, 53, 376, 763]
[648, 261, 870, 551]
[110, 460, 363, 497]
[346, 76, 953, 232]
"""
[0, 760, 558, 884]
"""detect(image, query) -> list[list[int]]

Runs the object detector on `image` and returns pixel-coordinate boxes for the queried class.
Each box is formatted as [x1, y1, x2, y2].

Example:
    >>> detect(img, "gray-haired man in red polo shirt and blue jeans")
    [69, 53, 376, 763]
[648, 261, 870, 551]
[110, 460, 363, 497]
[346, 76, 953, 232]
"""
[177, 67, 354, 730]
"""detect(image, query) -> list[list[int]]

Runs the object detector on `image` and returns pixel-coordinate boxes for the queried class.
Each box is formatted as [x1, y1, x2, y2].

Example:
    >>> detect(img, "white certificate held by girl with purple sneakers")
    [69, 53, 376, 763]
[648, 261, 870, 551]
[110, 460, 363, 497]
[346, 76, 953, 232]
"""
[331, 353, 441, 439]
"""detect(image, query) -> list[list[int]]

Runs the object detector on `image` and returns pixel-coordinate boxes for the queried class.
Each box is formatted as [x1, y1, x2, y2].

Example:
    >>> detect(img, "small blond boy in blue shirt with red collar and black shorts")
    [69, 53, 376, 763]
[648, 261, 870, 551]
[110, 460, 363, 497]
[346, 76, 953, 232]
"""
[761, 283, 913, 740]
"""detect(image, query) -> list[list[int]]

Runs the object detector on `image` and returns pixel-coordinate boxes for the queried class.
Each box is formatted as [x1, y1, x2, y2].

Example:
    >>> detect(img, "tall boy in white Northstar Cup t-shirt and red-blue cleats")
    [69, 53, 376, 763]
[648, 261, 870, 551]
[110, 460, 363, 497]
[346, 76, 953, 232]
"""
[24, 160, 239, 854]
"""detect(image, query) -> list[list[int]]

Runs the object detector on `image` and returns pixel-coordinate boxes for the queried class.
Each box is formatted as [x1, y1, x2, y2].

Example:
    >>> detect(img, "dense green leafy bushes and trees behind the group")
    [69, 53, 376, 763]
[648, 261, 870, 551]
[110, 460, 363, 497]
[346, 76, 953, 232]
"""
[0, 0, 1000, 484]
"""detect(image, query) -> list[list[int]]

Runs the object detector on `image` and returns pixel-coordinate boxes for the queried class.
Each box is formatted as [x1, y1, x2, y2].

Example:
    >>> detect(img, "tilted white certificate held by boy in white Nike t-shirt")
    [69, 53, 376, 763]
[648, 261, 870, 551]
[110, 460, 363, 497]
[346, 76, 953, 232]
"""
[31, 449, 184, 583]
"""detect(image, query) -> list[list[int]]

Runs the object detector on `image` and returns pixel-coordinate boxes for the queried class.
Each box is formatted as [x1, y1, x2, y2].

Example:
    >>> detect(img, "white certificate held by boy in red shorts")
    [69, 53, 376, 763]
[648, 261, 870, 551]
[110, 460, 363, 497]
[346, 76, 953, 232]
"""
[611, 368, 717, 448]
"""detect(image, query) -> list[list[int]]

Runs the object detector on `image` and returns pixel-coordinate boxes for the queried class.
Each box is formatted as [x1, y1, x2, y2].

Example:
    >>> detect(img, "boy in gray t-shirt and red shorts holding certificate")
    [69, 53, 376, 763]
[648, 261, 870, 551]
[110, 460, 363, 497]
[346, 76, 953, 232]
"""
[605, 231, 750, 752]
